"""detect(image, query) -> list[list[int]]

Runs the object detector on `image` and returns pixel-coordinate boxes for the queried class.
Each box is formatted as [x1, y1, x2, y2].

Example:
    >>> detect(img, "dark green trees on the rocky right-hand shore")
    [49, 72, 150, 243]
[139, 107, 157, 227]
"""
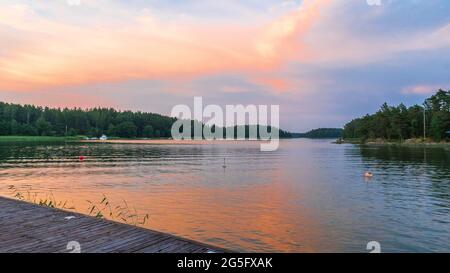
[343, 89, 450, 141]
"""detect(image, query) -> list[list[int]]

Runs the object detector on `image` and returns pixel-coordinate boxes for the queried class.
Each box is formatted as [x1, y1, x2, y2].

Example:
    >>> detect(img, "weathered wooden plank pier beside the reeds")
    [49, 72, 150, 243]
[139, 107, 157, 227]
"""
[0, 197, 224, 253]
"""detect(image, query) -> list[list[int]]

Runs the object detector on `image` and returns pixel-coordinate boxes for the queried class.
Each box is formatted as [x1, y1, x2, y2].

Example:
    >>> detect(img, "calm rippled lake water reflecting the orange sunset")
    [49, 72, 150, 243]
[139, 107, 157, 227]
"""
[0, 140, 450, 252]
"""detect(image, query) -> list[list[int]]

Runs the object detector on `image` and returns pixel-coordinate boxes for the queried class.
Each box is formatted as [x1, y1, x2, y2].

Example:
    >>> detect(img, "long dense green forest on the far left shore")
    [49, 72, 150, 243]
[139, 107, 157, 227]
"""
[0, 102, 291, 138]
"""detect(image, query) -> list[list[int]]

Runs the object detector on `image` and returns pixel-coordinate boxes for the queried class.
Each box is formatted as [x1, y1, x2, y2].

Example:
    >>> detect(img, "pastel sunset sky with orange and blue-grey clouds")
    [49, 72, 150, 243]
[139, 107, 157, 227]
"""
[0, 0, 450, 132]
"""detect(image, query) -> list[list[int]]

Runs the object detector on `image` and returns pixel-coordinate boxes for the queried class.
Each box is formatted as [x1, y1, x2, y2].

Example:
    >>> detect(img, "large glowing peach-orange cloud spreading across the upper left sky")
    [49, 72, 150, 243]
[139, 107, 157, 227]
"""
[0, 0, 329, 90]
